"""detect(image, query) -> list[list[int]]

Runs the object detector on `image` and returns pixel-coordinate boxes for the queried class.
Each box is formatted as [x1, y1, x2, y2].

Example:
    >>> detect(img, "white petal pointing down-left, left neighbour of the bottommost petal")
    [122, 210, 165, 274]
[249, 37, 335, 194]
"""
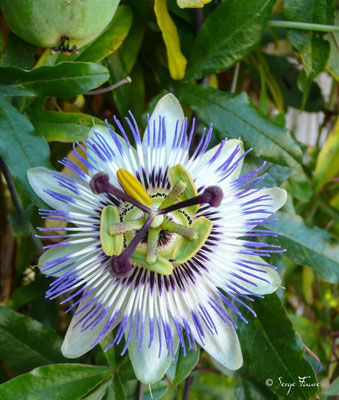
[61, 291, 121, 358]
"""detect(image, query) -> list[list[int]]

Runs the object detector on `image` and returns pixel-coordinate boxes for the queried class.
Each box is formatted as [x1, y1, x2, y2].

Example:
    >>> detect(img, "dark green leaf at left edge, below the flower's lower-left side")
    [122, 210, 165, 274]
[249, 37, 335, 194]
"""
[0, 307, 66, 376]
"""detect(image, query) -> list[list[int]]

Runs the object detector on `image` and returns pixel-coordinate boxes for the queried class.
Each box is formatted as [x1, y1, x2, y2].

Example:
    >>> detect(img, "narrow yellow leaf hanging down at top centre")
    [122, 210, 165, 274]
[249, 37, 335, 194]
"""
[154, 0, 187, 80]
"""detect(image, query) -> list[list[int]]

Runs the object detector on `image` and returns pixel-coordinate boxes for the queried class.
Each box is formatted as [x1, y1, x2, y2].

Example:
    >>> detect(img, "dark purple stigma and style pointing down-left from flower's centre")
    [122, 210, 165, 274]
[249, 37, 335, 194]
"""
[110, 214, 154, 278]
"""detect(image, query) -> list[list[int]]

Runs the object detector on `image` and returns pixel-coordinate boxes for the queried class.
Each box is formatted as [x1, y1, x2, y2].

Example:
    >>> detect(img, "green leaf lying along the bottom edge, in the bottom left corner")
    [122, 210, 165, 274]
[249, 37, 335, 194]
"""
[0, 364, 112, 400]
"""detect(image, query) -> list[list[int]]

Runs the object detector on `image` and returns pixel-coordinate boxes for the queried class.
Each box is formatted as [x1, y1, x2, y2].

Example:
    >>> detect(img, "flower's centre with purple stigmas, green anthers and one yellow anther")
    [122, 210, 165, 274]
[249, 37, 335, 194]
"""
[90, 164, 223, 278]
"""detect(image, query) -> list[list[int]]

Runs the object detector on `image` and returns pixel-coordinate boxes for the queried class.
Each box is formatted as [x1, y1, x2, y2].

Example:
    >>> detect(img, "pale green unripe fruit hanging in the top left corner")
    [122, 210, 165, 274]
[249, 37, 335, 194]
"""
[0, 0, 120, 48]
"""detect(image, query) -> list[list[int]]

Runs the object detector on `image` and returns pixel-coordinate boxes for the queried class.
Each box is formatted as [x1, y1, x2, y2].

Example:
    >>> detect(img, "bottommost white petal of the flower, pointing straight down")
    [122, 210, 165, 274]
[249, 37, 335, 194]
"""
[128, 314, 179, 385]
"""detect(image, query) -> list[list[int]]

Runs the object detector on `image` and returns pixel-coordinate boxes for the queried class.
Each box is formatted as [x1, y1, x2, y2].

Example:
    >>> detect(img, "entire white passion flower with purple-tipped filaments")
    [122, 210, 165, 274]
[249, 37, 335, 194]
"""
[28, 94, 286, 383]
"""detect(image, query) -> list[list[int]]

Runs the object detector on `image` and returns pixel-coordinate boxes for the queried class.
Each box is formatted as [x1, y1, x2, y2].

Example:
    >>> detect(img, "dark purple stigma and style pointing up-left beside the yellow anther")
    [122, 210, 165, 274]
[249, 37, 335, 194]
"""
[89, 172, 151, 214]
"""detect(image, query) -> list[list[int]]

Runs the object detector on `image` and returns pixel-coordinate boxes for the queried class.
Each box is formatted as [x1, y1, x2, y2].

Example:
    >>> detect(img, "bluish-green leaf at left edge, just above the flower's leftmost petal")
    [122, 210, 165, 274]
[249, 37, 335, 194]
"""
[0, 97, 51, 204]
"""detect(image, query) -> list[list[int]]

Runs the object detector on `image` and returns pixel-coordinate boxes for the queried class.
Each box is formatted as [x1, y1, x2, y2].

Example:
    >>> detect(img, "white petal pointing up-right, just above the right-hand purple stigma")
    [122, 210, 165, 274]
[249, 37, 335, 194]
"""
[190, 139, 244, 187]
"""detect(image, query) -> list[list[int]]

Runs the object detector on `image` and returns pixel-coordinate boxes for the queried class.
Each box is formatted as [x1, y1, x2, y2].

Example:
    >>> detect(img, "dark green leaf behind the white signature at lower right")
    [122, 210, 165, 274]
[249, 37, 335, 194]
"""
[237, 294, 318, 400]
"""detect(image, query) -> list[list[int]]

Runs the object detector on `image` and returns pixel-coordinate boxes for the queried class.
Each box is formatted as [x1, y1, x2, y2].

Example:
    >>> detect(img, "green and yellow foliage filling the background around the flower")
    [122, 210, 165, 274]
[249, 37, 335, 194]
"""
[0, 0, 339, 400]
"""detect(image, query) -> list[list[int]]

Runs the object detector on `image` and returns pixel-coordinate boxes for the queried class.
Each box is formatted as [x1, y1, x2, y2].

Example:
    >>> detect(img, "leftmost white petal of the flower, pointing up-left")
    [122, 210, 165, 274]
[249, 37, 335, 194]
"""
[27, 167, 88, 214]
